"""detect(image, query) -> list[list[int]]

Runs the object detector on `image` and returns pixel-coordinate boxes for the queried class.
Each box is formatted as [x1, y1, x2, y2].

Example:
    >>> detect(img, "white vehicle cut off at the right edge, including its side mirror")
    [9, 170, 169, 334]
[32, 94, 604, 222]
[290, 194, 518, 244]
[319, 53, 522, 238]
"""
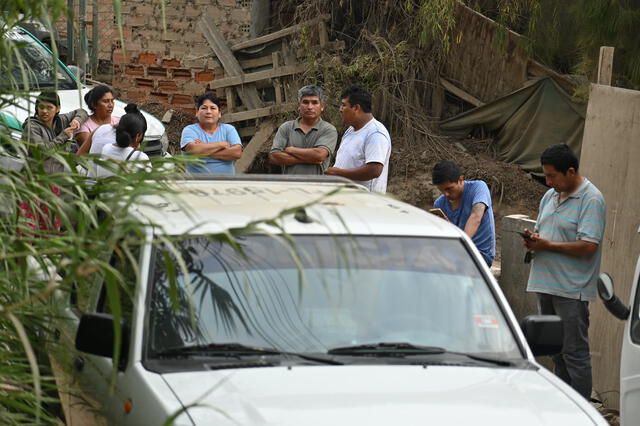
[598, 225, 640, 426]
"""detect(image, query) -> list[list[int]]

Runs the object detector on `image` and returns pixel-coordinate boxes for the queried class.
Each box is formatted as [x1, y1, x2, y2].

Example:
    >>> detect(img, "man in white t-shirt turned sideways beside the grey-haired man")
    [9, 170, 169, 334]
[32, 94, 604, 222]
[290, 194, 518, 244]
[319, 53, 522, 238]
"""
[324, 86, 391, 192]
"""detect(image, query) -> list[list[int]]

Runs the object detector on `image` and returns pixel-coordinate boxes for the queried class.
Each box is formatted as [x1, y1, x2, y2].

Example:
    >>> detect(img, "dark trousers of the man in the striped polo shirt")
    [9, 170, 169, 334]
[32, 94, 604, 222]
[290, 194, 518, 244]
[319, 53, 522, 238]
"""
[538, 293, 592, 400]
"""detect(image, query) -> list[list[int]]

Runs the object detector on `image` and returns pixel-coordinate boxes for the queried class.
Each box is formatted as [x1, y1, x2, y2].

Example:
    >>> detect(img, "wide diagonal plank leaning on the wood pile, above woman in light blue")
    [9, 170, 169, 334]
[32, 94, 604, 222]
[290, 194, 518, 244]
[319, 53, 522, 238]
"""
[198, 15, 263, 109]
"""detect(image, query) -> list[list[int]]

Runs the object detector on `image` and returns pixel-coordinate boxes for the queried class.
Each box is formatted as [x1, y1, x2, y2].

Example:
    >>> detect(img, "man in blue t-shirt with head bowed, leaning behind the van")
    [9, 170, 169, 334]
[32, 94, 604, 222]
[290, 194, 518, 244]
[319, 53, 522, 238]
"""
[431, 161, 496, 266]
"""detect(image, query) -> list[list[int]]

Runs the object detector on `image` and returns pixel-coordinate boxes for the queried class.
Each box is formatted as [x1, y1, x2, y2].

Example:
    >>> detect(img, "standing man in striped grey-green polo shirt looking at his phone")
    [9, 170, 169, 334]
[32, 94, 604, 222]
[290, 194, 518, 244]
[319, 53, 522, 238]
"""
[524, 144, 606, 399]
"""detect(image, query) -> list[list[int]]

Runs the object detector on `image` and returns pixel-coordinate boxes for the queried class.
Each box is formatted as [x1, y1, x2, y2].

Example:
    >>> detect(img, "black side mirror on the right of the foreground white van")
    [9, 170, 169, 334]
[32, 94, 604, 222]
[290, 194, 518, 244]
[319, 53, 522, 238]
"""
[520, 315, 564, 356]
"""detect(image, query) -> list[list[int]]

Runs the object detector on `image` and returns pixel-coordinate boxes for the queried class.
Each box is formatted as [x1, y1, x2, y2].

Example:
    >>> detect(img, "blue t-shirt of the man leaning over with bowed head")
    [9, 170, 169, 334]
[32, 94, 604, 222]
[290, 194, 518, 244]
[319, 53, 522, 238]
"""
[433, 180, 496, 266]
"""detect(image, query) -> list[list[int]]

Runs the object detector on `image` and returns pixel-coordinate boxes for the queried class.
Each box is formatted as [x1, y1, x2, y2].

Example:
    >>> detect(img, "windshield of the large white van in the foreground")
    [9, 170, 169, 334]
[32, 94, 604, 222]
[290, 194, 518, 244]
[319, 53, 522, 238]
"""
[146, 235, 522, 359]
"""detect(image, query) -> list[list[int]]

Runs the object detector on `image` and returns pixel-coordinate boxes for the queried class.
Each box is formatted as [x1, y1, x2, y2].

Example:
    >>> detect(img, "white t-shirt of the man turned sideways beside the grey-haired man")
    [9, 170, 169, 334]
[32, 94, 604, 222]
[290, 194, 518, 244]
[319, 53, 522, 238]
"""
[334, 118, 391, 193]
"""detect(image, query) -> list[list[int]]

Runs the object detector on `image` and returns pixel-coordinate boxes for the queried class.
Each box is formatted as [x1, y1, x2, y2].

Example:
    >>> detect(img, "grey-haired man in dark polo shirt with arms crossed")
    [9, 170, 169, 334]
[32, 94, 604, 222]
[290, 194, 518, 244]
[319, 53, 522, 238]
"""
[269, 86, 338, 175]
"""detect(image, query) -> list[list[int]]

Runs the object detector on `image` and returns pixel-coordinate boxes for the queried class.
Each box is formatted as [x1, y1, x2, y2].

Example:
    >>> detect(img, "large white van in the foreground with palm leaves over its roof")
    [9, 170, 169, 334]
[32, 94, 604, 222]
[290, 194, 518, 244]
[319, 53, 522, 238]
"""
[52, 175, 607, 426]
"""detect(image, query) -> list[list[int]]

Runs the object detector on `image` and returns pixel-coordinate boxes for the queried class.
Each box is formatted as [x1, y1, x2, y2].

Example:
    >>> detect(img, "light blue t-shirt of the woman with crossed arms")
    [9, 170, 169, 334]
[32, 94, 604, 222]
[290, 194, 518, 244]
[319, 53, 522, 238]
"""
[180, 123, 242, 174]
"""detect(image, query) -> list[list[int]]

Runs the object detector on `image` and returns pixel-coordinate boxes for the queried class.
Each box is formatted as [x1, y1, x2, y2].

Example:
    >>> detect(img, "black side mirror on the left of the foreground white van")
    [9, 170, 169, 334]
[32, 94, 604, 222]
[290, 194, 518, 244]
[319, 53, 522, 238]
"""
[76, 313, 129, 367]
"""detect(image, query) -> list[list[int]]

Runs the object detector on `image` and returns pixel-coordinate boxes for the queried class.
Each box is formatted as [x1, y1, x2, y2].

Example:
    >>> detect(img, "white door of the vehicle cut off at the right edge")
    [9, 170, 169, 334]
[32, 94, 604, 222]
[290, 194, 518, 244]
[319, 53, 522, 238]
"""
[620, 257, 640, 426]
